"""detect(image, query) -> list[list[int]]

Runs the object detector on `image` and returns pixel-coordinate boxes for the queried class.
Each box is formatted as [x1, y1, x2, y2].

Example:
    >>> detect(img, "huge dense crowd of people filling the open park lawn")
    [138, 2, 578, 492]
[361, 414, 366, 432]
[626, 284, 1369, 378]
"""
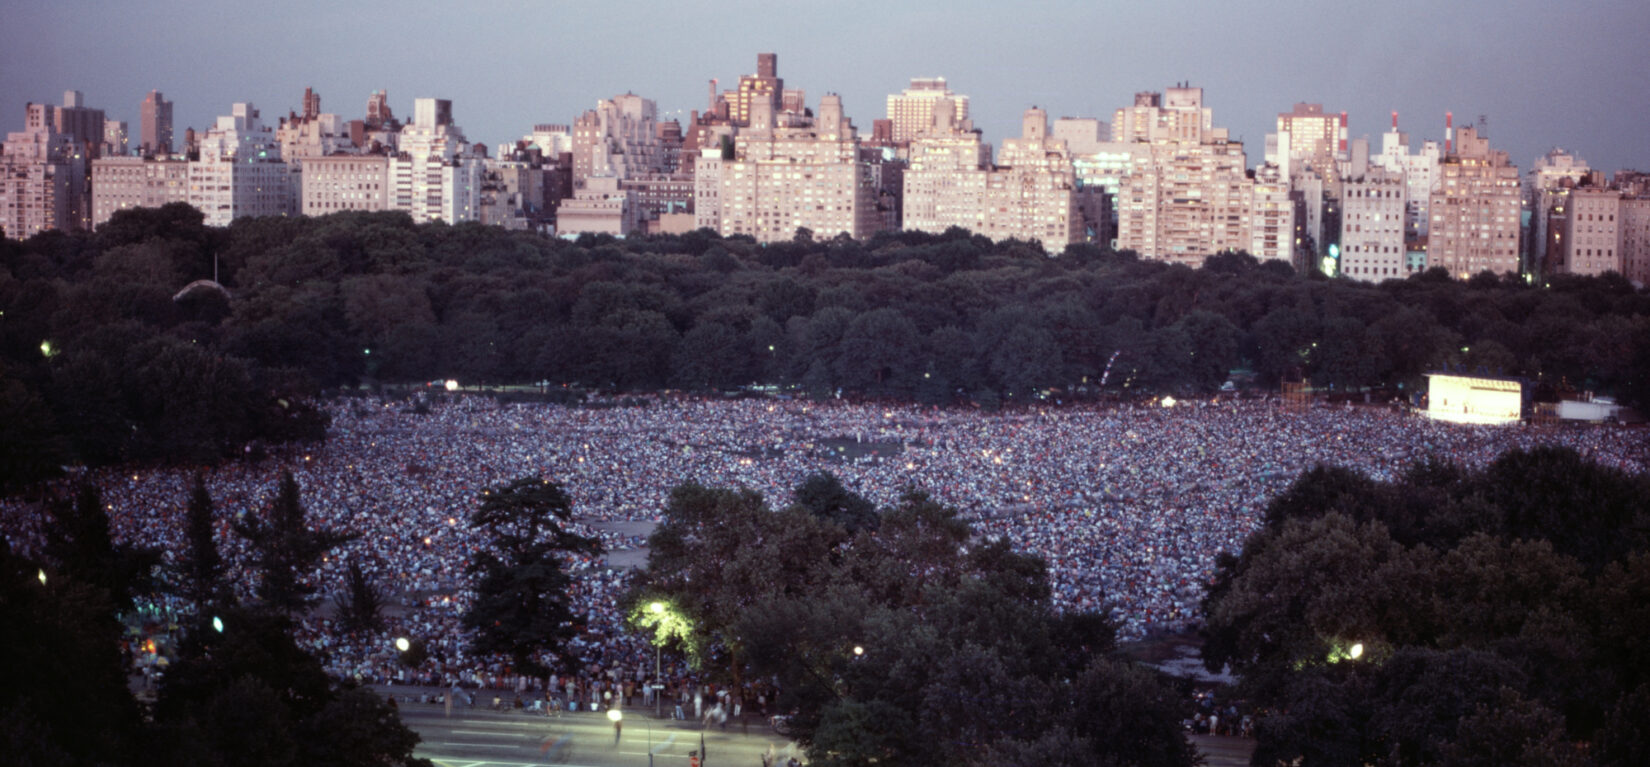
[0, 396, 1647, 701]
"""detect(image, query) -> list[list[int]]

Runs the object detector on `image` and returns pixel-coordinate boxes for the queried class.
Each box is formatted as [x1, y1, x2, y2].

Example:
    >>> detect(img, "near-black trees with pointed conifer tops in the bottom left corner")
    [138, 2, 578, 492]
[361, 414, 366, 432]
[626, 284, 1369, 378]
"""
[0, 473, 431, 767]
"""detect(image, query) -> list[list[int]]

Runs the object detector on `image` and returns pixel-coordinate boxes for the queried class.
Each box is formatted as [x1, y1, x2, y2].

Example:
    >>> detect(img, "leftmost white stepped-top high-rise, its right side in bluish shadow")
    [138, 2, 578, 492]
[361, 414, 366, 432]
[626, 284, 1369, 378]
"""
[190, 104, 295, 226]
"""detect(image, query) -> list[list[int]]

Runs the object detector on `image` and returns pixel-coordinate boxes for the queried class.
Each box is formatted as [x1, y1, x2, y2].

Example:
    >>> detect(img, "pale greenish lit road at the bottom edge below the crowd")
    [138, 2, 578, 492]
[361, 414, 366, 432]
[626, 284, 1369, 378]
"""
[401, 703, 802, 767]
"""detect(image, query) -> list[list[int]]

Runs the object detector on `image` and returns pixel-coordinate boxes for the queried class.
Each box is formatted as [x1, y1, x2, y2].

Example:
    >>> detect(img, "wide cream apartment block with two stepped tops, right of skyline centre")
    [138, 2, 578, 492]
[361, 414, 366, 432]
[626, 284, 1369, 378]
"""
[904, 104, 1082, 254]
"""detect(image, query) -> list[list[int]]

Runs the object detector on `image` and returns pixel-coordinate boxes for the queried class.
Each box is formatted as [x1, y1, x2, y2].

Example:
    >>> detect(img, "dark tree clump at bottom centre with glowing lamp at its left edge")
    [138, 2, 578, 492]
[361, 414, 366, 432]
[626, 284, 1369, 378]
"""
[630, 475, 1195, 765]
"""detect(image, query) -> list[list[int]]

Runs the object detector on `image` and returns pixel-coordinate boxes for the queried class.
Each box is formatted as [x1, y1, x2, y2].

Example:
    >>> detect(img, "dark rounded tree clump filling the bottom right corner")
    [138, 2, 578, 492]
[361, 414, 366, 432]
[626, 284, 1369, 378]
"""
[1205, 449, 1650, 765]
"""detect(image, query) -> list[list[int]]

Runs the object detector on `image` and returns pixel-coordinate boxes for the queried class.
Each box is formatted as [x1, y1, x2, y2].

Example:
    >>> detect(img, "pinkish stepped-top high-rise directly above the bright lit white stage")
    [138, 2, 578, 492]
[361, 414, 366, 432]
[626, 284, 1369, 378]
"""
[1427, 127, 1523, 279]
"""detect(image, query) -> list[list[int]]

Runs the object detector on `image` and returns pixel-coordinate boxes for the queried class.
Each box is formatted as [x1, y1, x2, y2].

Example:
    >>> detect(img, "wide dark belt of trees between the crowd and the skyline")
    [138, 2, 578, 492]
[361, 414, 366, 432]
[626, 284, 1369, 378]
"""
[0, 205, 1650, 482]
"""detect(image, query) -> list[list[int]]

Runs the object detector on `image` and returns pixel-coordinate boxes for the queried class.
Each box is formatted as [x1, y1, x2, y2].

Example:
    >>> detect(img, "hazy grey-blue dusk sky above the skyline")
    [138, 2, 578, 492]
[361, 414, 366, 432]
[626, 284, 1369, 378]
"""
[0, 0, 1650, 172]
